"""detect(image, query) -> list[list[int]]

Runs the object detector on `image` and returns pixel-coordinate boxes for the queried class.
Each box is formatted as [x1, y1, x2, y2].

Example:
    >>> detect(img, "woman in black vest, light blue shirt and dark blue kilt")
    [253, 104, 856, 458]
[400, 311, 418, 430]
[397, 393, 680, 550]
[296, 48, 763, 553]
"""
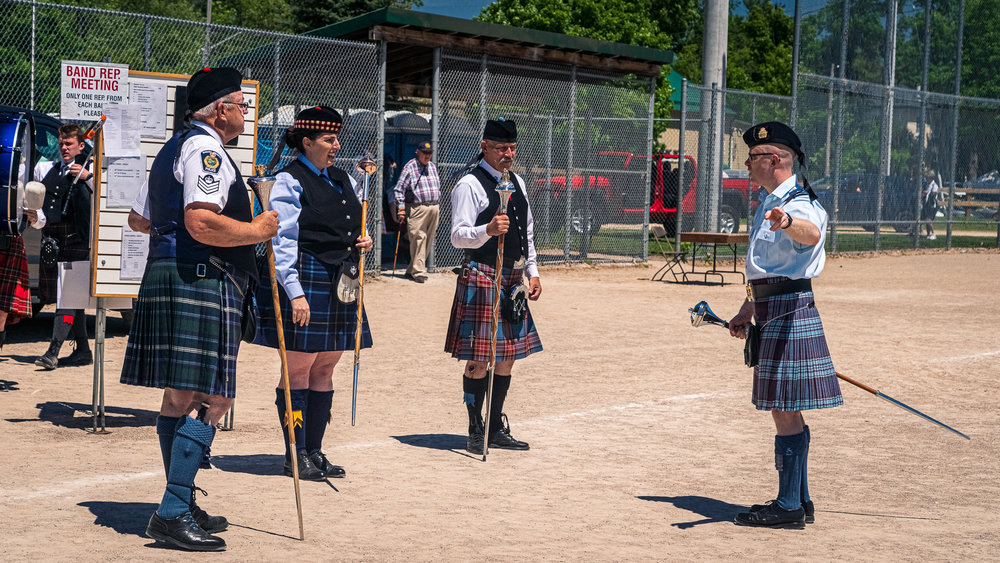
[255, 106, 372, 481]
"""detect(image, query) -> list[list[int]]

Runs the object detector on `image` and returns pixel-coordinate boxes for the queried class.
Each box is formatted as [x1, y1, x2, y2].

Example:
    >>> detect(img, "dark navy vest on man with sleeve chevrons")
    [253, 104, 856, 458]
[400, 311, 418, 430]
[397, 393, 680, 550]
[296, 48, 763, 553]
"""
[149, 127, 258, 280]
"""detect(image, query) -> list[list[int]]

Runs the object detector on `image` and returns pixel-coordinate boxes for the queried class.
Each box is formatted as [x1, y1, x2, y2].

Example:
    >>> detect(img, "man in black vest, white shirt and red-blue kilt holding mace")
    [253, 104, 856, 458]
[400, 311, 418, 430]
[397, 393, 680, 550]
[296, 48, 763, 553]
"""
[444, 118, 542, 454]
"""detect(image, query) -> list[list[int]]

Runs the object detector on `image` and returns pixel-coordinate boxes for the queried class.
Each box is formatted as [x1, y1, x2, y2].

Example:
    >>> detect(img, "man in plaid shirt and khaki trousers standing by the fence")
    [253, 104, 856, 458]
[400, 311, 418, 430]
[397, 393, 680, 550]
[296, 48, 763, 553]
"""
[394, 141, 441, 283]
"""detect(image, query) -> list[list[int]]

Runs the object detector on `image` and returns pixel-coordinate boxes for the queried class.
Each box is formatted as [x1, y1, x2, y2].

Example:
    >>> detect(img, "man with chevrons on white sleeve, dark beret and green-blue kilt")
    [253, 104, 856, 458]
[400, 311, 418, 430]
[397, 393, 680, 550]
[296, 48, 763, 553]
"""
[121, 68, 278, 551]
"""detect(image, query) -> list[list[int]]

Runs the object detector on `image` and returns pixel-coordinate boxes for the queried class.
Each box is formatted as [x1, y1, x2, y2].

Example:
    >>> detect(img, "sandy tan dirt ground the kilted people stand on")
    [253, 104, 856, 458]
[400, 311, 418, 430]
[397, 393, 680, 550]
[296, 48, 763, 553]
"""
[0, 251, 1000, 561]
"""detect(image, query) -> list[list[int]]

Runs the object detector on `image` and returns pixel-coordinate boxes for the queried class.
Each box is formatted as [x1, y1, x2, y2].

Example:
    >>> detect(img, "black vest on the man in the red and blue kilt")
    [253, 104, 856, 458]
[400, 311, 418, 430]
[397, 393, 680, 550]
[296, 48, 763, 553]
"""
[465, 166, 528, 268]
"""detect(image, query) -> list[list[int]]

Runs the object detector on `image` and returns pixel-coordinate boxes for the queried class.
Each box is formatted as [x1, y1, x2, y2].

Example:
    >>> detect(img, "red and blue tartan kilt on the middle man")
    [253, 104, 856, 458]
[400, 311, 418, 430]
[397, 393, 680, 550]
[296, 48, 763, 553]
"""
[444, 262, 542, 362]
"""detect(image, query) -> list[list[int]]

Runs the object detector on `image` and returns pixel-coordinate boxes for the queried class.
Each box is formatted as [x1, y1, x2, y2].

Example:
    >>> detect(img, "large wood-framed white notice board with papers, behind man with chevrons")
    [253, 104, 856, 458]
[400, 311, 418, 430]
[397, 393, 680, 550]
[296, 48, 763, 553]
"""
[90, 71, 259, 297]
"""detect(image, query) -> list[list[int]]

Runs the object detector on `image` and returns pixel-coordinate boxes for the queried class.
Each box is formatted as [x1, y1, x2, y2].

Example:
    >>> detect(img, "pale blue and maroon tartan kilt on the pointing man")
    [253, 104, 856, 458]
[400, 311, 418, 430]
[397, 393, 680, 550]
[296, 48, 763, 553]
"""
[753, 277, 844, 411]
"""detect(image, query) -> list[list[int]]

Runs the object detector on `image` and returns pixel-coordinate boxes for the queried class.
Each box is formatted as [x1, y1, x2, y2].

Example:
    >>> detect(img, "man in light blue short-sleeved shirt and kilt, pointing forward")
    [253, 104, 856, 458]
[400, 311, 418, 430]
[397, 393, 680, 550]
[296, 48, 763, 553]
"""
[729, 122, 843, 528]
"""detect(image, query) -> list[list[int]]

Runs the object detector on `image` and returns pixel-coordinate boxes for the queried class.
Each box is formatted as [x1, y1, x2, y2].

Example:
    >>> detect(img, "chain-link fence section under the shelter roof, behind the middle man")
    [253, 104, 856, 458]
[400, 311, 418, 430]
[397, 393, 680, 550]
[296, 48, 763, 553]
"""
[434, 50, 652, 268]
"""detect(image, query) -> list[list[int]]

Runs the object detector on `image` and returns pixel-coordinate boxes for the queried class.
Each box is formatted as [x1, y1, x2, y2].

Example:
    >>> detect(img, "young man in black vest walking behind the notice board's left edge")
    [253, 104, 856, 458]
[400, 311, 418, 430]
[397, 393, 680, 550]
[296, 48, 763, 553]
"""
[35, 123, 94, 370]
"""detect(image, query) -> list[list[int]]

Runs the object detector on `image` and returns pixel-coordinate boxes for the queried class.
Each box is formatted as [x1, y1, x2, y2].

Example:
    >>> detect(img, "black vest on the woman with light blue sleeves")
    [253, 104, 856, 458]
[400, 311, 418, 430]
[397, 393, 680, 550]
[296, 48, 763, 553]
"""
[281, 160, 362, 266]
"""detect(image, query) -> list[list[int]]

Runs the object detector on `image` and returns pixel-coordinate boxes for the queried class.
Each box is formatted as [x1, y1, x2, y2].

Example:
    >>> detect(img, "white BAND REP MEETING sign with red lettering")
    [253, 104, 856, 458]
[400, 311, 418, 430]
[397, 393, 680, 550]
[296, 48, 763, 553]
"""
[59, 61, 129, 121]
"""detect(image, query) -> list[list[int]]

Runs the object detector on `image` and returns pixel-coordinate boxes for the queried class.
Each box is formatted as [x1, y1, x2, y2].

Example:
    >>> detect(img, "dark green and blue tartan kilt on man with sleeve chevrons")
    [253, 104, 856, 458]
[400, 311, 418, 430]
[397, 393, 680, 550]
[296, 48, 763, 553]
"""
[121, 259, 248, 398]
